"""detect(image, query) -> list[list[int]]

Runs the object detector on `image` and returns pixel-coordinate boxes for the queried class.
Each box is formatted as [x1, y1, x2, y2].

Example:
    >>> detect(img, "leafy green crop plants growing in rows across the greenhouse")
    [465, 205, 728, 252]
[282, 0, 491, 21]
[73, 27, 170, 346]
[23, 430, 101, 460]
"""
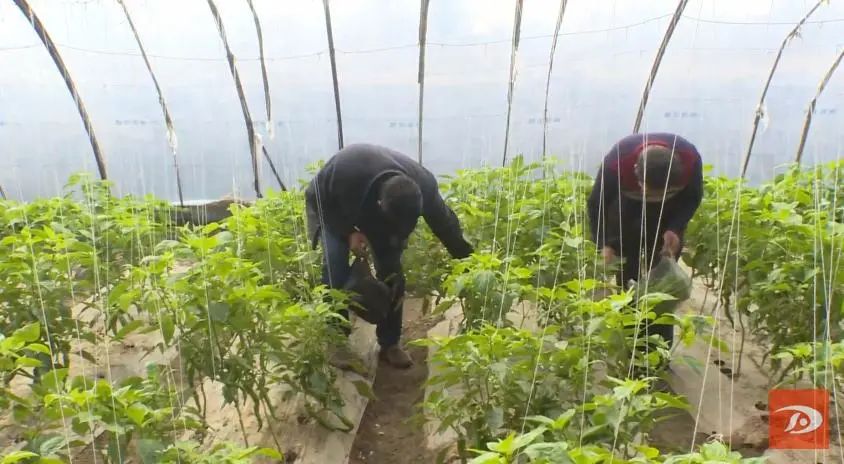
[0, 158, 844, 463]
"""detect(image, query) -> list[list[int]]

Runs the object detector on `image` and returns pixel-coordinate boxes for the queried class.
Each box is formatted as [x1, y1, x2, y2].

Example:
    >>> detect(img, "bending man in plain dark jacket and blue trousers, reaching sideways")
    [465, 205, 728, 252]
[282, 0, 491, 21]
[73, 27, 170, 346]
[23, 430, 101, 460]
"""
[305, 144, 473, 368]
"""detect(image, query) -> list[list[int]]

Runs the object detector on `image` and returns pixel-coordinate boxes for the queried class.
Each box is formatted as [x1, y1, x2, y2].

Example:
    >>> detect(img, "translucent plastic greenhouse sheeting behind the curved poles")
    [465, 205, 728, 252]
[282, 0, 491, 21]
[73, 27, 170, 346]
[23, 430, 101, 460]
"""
[0, 0, 844, 200]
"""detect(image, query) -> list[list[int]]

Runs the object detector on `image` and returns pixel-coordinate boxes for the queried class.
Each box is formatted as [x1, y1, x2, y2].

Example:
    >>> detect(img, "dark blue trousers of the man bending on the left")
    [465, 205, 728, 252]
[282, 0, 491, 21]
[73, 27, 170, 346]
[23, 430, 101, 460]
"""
[320, 230, 405, 348]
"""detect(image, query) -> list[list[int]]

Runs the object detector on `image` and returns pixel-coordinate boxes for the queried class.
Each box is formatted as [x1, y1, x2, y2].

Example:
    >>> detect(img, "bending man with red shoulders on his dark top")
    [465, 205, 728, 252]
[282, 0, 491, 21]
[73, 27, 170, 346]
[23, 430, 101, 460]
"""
[588, 133, 703, 345]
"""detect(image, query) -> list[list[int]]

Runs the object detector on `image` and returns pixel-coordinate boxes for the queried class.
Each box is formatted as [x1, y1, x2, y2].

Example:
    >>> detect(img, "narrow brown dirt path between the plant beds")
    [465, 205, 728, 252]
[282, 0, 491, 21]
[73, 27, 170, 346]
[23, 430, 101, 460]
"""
[349, 300, 435, 464]
